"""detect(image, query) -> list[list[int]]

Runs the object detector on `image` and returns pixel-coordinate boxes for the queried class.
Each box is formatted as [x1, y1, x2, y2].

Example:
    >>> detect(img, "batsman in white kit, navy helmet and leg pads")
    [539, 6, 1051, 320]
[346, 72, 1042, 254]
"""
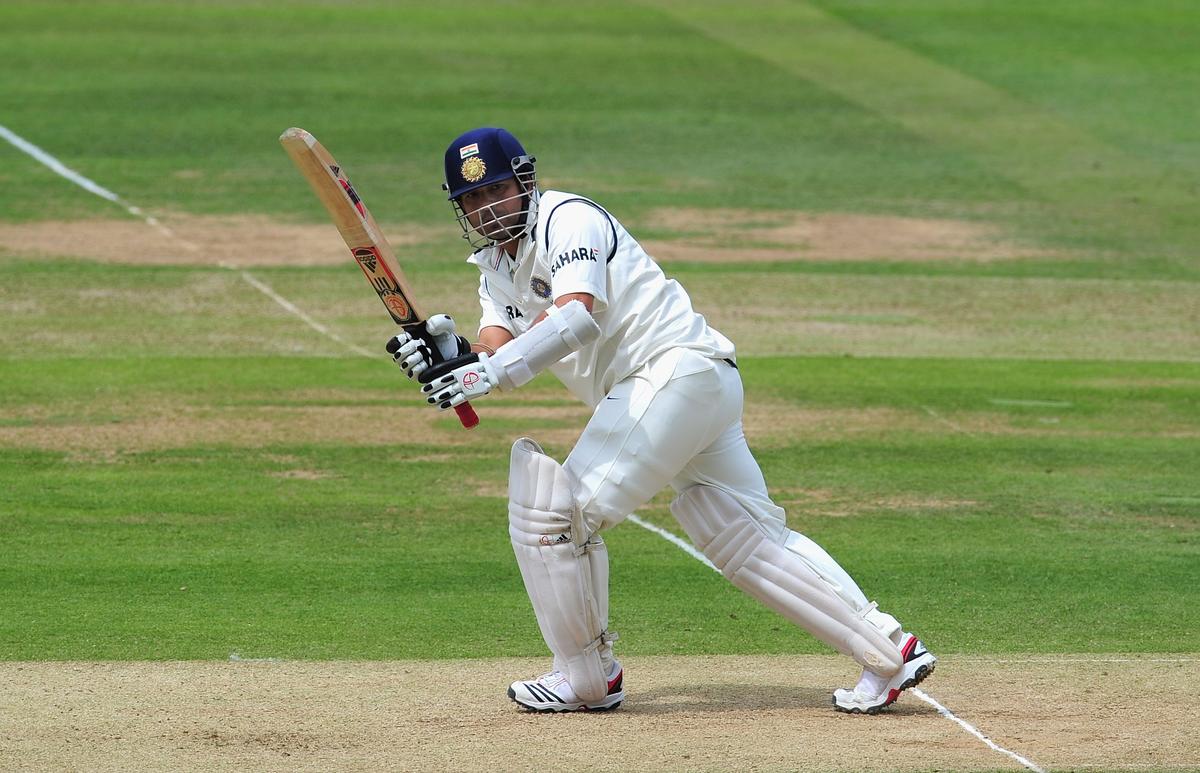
[388, 127, 937, 714]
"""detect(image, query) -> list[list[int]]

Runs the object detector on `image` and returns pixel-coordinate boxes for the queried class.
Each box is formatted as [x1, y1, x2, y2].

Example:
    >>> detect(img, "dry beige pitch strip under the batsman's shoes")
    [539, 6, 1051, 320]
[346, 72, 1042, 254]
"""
[0, 655, 1200, 771]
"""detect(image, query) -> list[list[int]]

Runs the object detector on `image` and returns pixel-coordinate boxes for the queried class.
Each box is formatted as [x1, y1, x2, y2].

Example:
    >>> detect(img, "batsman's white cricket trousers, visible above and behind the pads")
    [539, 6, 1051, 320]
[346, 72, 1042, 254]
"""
[564, 348, 868, 609]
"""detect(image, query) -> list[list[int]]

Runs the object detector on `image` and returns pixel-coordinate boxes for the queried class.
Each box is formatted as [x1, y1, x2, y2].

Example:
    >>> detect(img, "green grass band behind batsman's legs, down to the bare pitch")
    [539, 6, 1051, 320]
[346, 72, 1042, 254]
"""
[0, 358, 1200, 659]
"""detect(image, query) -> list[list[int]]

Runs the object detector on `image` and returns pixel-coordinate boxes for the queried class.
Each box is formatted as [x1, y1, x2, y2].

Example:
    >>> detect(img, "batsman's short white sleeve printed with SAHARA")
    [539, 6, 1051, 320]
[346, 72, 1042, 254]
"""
[546, 199, 617, 311]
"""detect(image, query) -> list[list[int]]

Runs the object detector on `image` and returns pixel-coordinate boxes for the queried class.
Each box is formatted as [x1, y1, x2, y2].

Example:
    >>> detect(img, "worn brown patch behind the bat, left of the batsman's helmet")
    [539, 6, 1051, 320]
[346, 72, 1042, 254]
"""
[0, 214, 448, 268]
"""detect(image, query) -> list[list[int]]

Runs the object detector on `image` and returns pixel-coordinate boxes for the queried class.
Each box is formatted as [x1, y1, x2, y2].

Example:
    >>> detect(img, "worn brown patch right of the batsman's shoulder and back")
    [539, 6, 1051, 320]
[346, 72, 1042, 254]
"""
[643, 209, 1056, 262]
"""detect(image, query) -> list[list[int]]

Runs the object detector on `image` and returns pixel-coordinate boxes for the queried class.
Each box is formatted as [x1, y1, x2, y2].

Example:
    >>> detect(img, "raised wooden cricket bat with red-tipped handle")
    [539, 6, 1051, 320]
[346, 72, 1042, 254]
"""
[280, 128, 479, 429]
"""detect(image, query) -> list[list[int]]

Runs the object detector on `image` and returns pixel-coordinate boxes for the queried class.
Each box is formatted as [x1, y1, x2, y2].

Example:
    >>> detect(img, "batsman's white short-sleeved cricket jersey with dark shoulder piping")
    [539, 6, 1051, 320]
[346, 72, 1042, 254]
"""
[468, 191, 734, 407]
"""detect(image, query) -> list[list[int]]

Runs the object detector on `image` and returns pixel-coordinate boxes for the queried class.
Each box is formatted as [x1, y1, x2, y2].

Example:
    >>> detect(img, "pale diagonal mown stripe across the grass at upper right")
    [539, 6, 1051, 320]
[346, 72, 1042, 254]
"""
[646, 0, 1193, 250]
